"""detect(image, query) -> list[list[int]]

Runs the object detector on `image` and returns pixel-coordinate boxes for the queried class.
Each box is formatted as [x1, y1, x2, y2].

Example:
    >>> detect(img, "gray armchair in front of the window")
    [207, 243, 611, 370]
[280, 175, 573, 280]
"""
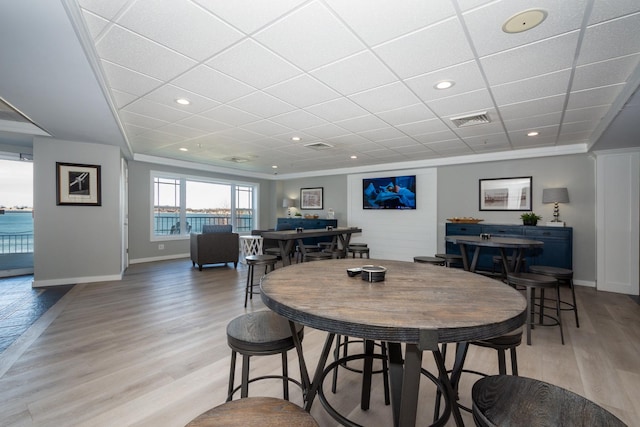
[191, 225, 240, 271]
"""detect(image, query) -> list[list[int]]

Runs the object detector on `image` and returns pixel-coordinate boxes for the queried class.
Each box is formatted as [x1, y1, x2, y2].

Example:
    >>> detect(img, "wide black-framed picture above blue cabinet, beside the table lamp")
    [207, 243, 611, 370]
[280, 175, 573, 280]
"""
[479, 176, 532, 211]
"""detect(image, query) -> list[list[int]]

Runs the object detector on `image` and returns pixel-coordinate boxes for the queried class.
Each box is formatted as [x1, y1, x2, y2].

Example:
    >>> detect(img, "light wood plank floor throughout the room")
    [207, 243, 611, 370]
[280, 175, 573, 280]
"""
[0, 260, 640, 427]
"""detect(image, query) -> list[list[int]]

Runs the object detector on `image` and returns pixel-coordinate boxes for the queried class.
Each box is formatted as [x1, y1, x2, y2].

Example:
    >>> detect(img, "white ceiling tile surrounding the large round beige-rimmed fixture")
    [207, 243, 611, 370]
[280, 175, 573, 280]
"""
[464, 0, 587, 56]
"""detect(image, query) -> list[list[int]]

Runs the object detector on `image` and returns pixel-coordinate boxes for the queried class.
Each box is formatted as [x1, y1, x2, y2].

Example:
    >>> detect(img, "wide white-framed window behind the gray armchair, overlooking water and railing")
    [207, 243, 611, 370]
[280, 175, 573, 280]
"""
[151, 172, 257, 237]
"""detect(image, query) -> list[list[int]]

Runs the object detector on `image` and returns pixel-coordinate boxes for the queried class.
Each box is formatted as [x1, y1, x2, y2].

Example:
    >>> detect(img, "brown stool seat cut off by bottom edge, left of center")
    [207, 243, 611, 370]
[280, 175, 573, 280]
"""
[185, 397, 318, 427]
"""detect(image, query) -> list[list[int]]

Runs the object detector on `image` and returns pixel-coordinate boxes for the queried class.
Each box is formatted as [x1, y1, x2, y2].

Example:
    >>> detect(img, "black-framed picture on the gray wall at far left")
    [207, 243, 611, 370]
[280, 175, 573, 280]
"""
[56, 162, 102, 206]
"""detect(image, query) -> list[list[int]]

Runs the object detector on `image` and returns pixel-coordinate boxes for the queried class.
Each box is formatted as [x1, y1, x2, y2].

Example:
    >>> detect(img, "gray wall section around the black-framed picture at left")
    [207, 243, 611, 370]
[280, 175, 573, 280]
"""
[33, 138, 122, 286]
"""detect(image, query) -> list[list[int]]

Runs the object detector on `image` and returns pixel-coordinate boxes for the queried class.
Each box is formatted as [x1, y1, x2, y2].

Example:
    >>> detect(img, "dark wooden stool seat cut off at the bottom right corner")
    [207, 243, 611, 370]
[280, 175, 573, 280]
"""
[471, 375, 625, 427]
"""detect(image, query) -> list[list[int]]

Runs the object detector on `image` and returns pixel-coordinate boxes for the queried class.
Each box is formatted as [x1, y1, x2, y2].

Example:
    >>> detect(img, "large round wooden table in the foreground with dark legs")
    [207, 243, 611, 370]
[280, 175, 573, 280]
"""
[261, 259, 527, 426]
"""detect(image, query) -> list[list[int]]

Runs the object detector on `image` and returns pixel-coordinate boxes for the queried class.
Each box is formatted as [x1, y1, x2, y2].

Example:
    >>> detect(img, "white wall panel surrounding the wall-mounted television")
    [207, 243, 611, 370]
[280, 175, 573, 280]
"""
[347, 169, 438, 261]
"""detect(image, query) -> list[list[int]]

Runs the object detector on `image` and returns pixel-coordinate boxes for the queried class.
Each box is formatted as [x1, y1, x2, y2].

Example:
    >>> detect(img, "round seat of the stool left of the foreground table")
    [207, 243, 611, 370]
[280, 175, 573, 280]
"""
[227, 310, 303, 353]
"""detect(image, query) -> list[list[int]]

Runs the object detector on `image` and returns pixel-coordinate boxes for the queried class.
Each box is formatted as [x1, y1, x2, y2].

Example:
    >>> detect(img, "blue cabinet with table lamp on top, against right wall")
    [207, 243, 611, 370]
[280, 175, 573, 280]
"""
[445, 223, 573, 271]
